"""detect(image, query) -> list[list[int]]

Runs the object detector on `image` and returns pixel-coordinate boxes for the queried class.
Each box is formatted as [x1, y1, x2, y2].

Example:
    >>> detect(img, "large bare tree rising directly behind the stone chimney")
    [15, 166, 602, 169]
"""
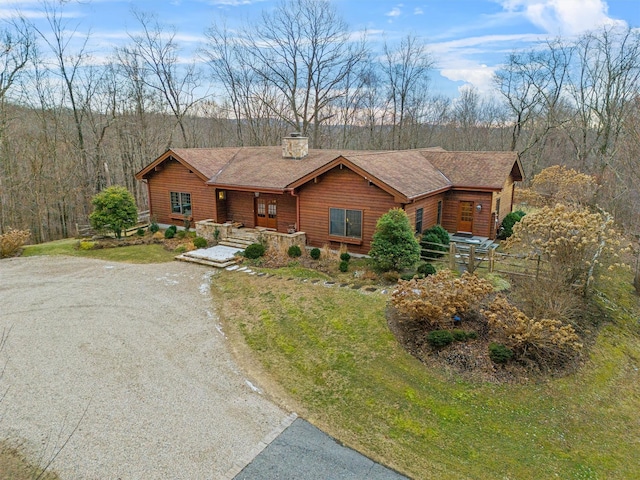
[243, 0, 366, 148]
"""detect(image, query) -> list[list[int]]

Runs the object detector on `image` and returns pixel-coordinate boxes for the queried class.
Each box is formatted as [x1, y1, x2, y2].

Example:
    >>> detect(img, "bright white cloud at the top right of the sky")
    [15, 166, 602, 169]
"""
[498, 0, 626, 36]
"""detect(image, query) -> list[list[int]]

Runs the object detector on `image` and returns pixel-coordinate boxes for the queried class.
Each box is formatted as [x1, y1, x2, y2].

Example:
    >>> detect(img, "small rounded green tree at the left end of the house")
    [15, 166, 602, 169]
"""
[89, 186, 138, 238]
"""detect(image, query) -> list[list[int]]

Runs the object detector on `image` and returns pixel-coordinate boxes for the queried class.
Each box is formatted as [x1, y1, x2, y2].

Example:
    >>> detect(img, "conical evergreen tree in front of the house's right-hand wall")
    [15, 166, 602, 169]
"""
[369, 208, 420, 271]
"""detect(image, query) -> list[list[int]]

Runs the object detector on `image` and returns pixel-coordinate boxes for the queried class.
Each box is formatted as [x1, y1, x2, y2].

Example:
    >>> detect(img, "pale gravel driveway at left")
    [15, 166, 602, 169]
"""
[0, 257, 293, 480]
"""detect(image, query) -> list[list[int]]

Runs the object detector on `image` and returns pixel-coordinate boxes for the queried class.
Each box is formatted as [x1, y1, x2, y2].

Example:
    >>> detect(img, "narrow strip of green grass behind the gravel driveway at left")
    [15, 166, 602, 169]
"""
[22, 238, 176, 263]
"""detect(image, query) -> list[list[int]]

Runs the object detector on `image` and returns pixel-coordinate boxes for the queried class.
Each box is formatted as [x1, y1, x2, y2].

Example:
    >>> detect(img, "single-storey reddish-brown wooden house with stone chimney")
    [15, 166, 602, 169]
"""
[136, 134, 523, 253]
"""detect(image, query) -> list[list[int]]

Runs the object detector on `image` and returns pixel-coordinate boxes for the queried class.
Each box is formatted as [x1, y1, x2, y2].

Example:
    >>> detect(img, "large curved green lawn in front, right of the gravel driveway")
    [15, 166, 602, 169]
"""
[213, 272, 640, 479]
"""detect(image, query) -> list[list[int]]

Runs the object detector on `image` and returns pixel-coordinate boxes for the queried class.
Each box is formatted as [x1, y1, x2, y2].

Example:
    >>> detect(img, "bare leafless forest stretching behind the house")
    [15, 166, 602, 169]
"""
[0, 0, 640, 242]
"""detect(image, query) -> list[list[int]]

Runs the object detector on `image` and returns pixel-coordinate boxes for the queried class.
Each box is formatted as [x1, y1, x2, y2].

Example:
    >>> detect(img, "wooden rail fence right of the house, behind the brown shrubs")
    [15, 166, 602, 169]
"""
[422, 242, 549, 278]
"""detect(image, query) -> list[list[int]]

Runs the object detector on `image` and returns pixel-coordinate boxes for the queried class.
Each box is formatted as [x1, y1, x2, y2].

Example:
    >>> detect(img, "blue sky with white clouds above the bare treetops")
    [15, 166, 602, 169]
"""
[0, 0, 640, 97]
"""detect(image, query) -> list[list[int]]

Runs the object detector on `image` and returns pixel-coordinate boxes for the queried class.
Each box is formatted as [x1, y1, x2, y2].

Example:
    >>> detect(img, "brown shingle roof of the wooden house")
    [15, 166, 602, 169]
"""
[137, 147, 520, 199]
